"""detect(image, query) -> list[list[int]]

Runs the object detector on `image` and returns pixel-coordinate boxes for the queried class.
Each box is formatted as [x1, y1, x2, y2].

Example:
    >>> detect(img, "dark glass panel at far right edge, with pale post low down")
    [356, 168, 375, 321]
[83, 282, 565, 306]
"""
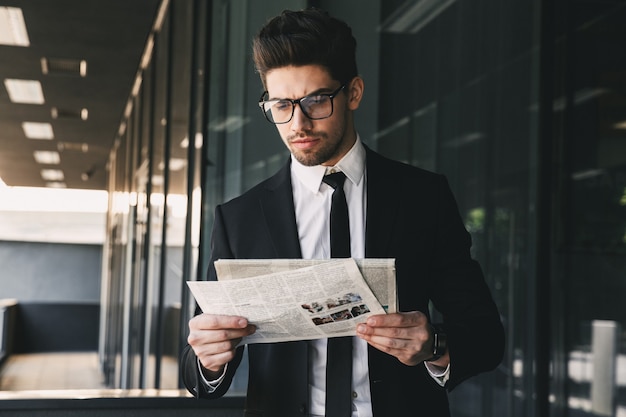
[551, 0, 626, 416]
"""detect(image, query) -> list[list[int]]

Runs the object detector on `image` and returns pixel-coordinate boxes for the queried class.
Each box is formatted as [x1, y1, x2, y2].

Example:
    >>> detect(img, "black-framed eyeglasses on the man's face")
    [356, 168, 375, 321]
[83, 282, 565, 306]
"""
[259, 84, 346, 125]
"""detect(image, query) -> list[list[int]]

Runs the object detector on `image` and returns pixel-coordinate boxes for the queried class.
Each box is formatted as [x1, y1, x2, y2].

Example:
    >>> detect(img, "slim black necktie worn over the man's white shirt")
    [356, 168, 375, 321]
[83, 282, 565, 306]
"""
[323, 172, 352, 417]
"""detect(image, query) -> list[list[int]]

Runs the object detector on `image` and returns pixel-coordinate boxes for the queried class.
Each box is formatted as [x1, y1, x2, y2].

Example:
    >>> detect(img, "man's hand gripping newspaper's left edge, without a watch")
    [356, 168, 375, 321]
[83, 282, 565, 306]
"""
[187, 314, 256, 379]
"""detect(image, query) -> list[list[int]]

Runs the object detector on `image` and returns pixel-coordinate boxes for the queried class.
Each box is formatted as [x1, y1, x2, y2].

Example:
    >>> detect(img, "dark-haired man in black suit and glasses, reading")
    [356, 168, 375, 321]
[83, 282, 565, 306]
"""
[182, 9, 504, 417]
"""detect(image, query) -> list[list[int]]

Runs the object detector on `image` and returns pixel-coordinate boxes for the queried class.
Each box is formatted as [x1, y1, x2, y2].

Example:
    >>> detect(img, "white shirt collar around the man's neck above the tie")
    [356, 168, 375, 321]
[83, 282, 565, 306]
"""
[291, 134, 365, 193]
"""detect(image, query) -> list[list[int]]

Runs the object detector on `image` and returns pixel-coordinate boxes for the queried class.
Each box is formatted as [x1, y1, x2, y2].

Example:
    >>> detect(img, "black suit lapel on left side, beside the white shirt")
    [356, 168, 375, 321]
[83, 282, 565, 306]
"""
[260, 158, 302, 258]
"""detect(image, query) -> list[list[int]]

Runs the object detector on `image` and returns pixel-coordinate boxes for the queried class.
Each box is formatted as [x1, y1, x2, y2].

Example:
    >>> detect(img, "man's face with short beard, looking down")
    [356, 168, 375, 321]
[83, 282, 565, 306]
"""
[265, 65, 363, 166]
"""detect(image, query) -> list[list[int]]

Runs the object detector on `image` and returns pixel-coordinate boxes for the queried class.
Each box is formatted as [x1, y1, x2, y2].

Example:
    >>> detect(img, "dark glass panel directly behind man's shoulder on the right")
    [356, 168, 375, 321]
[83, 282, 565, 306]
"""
[374, 0, 539, 416]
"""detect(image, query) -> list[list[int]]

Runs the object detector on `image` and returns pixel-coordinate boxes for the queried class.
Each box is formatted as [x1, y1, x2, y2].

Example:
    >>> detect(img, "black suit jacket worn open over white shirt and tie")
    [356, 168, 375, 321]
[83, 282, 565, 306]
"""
[182, 148, 504, 417]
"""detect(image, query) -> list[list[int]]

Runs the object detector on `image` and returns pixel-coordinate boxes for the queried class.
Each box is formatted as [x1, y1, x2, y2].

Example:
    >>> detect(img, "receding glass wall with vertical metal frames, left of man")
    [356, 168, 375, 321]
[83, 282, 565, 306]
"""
[100, 0, 208, 389]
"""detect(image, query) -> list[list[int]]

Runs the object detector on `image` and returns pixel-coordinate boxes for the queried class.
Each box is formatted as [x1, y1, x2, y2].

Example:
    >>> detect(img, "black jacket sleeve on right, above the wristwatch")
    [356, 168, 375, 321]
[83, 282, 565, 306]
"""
[431, 177, 505, 390]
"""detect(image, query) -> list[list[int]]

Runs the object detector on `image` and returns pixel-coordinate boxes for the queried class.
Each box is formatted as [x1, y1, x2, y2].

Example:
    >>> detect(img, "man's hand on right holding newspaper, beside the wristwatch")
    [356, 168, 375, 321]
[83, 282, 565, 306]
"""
[356, 311, 450, 368]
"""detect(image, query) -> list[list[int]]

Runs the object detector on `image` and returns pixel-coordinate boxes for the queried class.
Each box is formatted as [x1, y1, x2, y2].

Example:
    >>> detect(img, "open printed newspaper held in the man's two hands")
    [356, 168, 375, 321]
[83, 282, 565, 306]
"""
[187, 258, 395, 344]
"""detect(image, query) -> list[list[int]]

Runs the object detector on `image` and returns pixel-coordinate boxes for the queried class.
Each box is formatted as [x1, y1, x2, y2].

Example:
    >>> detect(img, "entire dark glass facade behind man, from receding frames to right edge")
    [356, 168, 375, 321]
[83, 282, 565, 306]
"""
[100, 0, 626, 417]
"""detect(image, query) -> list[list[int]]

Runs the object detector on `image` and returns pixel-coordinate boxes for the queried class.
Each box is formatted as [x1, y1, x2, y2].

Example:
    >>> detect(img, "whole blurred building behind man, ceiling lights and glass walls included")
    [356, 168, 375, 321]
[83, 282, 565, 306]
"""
[0, 0, 626, 417]
